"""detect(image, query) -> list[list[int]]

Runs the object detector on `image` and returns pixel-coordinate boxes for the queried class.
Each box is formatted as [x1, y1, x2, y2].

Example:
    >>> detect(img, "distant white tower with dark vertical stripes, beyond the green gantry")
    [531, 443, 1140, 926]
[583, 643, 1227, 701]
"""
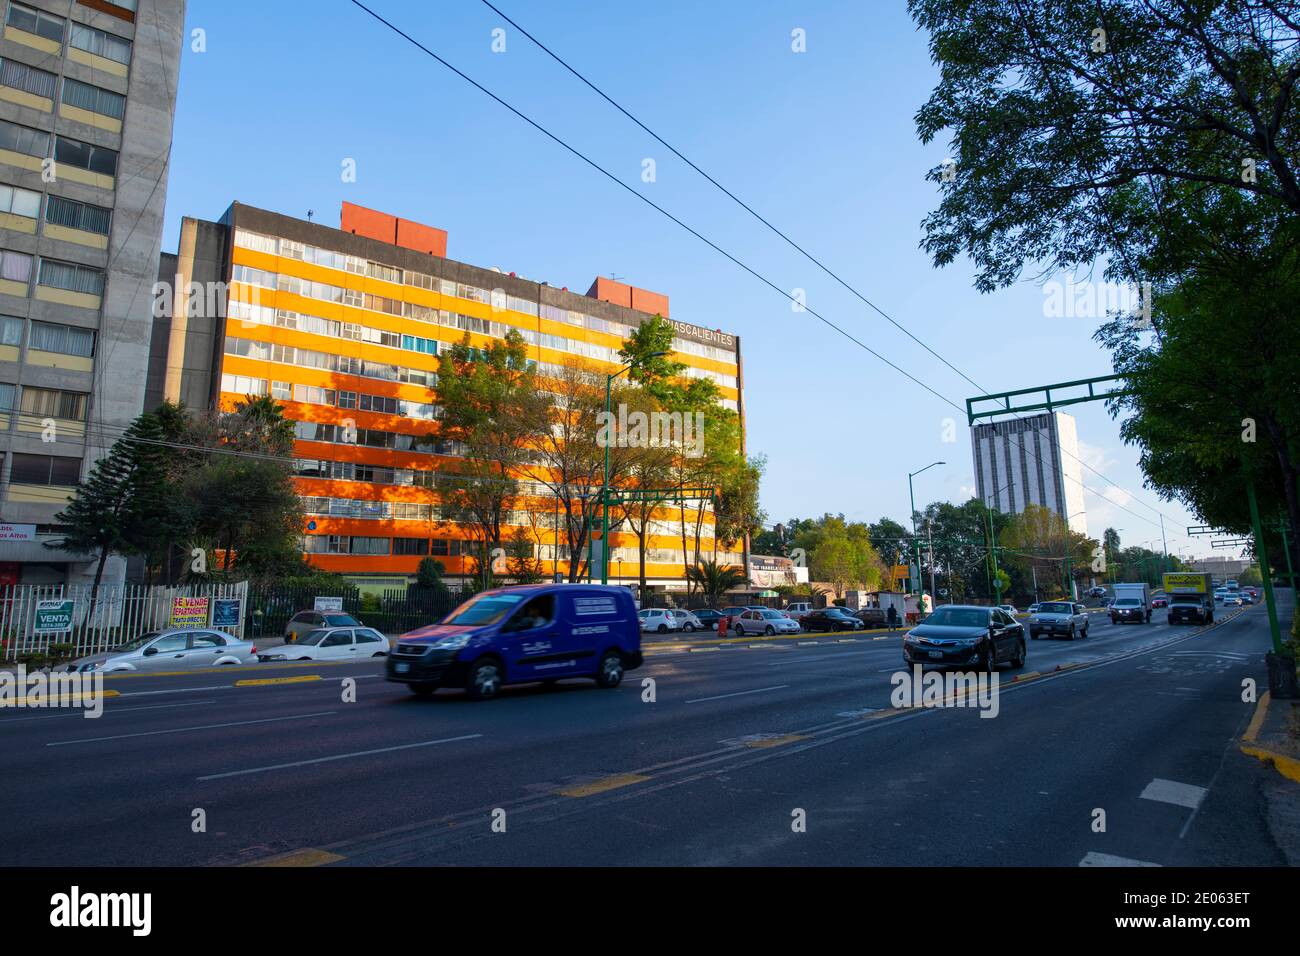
[971, 411, 1088, 535]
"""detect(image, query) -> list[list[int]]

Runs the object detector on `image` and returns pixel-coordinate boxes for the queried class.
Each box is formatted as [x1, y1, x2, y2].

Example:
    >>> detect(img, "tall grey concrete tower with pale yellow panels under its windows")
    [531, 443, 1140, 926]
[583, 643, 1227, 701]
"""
[0, 0, 185, 584]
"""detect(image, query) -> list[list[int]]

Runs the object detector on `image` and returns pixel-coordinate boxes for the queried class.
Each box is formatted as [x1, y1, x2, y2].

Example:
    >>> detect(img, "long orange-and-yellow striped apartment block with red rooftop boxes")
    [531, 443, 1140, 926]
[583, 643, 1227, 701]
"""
[146, 203, 744, 588]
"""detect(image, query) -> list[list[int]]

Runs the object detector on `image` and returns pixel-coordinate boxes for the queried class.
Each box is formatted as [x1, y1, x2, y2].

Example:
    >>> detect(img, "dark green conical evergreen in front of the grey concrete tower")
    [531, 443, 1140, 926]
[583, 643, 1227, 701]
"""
[55, 414, 169, 620]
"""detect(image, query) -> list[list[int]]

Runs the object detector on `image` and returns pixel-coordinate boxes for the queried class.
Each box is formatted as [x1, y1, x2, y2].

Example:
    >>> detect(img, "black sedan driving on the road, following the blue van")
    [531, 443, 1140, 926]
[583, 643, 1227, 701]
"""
[902, 605, 1026, 674]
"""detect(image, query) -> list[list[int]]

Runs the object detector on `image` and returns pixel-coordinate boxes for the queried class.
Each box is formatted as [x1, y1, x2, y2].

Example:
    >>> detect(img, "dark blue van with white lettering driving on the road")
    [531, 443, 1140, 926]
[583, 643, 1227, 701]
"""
[386, 584, 642, 700]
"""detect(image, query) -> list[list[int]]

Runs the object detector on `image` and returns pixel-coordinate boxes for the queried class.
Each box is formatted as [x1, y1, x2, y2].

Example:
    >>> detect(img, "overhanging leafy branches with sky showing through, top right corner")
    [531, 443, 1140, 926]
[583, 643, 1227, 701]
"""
[907, 0, 1300, 291]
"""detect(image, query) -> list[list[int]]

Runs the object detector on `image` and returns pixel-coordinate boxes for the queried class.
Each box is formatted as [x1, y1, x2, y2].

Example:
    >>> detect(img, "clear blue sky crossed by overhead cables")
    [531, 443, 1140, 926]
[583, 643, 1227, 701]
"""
[164, 0, 1226, 557]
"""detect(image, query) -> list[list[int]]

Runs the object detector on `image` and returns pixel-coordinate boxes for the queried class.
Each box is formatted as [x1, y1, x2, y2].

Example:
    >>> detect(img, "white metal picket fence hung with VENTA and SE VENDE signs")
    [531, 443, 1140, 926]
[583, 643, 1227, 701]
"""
[0, 581, 248, 661]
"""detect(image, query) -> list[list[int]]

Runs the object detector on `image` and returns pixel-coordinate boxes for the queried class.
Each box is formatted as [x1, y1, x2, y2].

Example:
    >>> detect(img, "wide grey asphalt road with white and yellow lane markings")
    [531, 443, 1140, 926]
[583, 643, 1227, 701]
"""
[0, 592, 1292, 866]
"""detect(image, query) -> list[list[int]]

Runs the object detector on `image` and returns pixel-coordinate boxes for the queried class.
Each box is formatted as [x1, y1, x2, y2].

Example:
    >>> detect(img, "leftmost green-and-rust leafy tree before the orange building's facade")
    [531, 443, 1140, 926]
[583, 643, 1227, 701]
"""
[428, 329, 550, 587]
